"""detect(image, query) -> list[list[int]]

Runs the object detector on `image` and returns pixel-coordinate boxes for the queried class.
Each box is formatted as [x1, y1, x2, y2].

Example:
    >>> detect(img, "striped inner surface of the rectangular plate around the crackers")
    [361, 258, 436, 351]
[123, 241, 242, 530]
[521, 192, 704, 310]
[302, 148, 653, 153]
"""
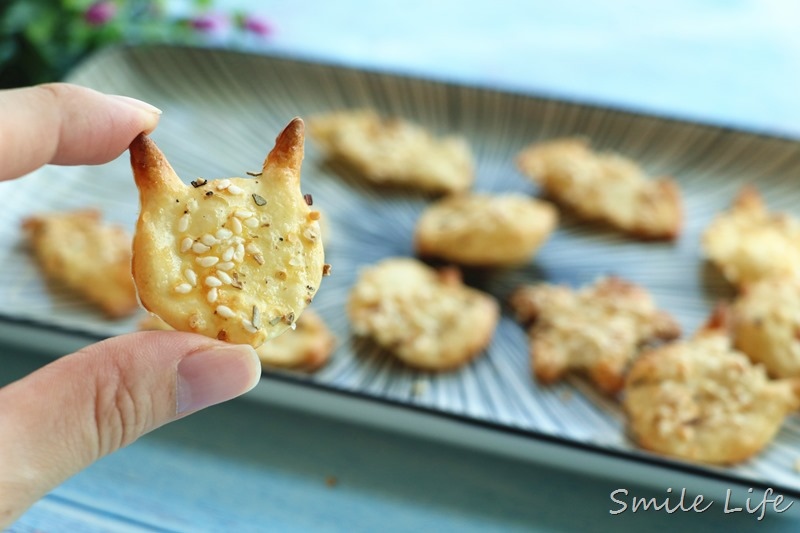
[0, 47, 800, 491]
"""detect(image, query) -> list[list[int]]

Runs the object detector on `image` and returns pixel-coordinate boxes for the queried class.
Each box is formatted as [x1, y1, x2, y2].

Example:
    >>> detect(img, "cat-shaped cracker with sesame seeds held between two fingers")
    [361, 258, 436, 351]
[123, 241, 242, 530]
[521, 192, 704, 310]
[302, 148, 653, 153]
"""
[130, 118, 325, 347]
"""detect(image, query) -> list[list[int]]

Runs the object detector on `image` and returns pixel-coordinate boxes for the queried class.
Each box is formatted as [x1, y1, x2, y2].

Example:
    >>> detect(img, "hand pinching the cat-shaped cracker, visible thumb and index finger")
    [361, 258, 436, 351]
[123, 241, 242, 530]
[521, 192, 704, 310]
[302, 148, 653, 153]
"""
[0, 84, 261, 529]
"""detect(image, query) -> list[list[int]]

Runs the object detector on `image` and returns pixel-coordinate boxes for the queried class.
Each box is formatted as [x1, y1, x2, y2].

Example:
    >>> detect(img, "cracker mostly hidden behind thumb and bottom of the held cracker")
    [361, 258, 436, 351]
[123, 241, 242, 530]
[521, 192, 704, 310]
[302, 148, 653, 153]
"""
[139, 308, 336, 372]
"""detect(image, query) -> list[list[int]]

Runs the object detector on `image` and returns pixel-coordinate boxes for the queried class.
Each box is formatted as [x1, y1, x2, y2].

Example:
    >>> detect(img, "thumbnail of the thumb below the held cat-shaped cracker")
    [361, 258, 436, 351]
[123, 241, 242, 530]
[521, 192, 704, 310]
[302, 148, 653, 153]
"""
[177, 345, 261, 415]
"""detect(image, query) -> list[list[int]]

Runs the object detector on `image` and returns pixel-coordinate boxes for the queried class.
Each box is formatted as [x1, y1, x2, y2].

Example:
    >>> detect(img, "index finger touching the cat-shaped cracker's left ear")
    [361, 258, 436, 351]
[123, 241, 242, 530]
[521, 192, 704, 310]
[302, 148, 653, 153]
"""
[0, 83, 161, 181]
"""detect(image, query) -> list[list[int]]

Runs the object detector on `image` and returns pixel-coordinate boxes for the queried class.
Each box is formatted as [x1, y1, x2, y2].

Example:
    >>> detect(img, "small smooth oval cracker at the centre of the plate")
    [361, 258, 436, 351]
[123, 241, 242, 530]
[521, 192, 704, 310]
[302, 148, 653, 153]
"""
[415, 194, 558, 266]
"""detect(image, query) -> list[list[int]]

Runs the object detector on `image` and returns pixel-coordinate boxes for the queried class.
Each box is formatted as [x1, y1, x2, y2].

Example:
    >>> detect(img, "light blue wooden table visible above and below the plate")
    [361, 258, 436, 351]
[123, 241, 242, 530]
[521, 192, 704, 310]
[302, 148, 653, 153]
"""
[6, 0, 800, 532]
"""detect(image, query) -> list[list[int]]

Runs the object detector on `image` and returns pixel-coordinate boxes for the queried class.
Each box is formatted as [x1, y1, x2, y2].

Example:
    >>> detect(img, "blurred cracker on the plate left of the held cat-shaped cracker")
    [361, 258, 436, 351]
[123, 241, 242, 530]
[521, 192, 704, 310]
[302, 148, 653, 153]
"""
[22, 209, 139, 318]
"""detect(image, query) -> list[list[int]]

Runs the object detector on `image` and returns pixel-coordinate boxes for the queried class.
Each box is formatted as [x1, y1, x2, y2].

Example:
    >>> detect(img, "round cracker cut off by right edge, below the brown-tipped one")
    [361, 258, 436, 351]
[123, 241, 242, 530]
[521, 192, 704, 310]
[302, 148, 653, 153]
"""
[732, 278, 800, 378]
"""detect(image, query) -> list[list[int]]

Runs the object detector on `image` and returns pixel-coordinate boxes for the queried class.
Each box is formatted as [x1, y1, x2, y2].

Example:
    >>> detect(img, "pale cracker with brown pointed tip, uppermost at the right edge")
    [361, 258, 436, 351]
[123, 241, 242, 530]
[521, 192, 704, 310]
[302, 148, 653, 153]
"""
[702, 187, 800, 288]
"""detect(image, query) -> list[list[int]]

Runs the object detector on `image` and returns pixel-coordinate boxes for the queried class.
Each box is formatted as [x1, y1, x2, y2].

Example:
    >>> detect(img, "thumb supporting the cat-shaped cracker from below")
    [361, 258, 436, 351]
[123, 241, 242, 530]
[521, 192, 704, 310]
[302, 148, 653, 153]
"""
[0, 331, 261, 529]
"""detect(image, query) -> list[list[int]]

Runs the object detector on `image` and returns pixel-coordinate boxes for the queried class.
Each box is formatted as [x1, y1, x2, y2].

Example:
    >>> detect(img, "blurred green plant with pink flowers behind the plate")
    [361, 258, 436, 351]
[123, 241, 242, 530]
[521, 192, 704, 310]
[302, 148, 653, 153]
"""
[0, 0, 272, 88]
